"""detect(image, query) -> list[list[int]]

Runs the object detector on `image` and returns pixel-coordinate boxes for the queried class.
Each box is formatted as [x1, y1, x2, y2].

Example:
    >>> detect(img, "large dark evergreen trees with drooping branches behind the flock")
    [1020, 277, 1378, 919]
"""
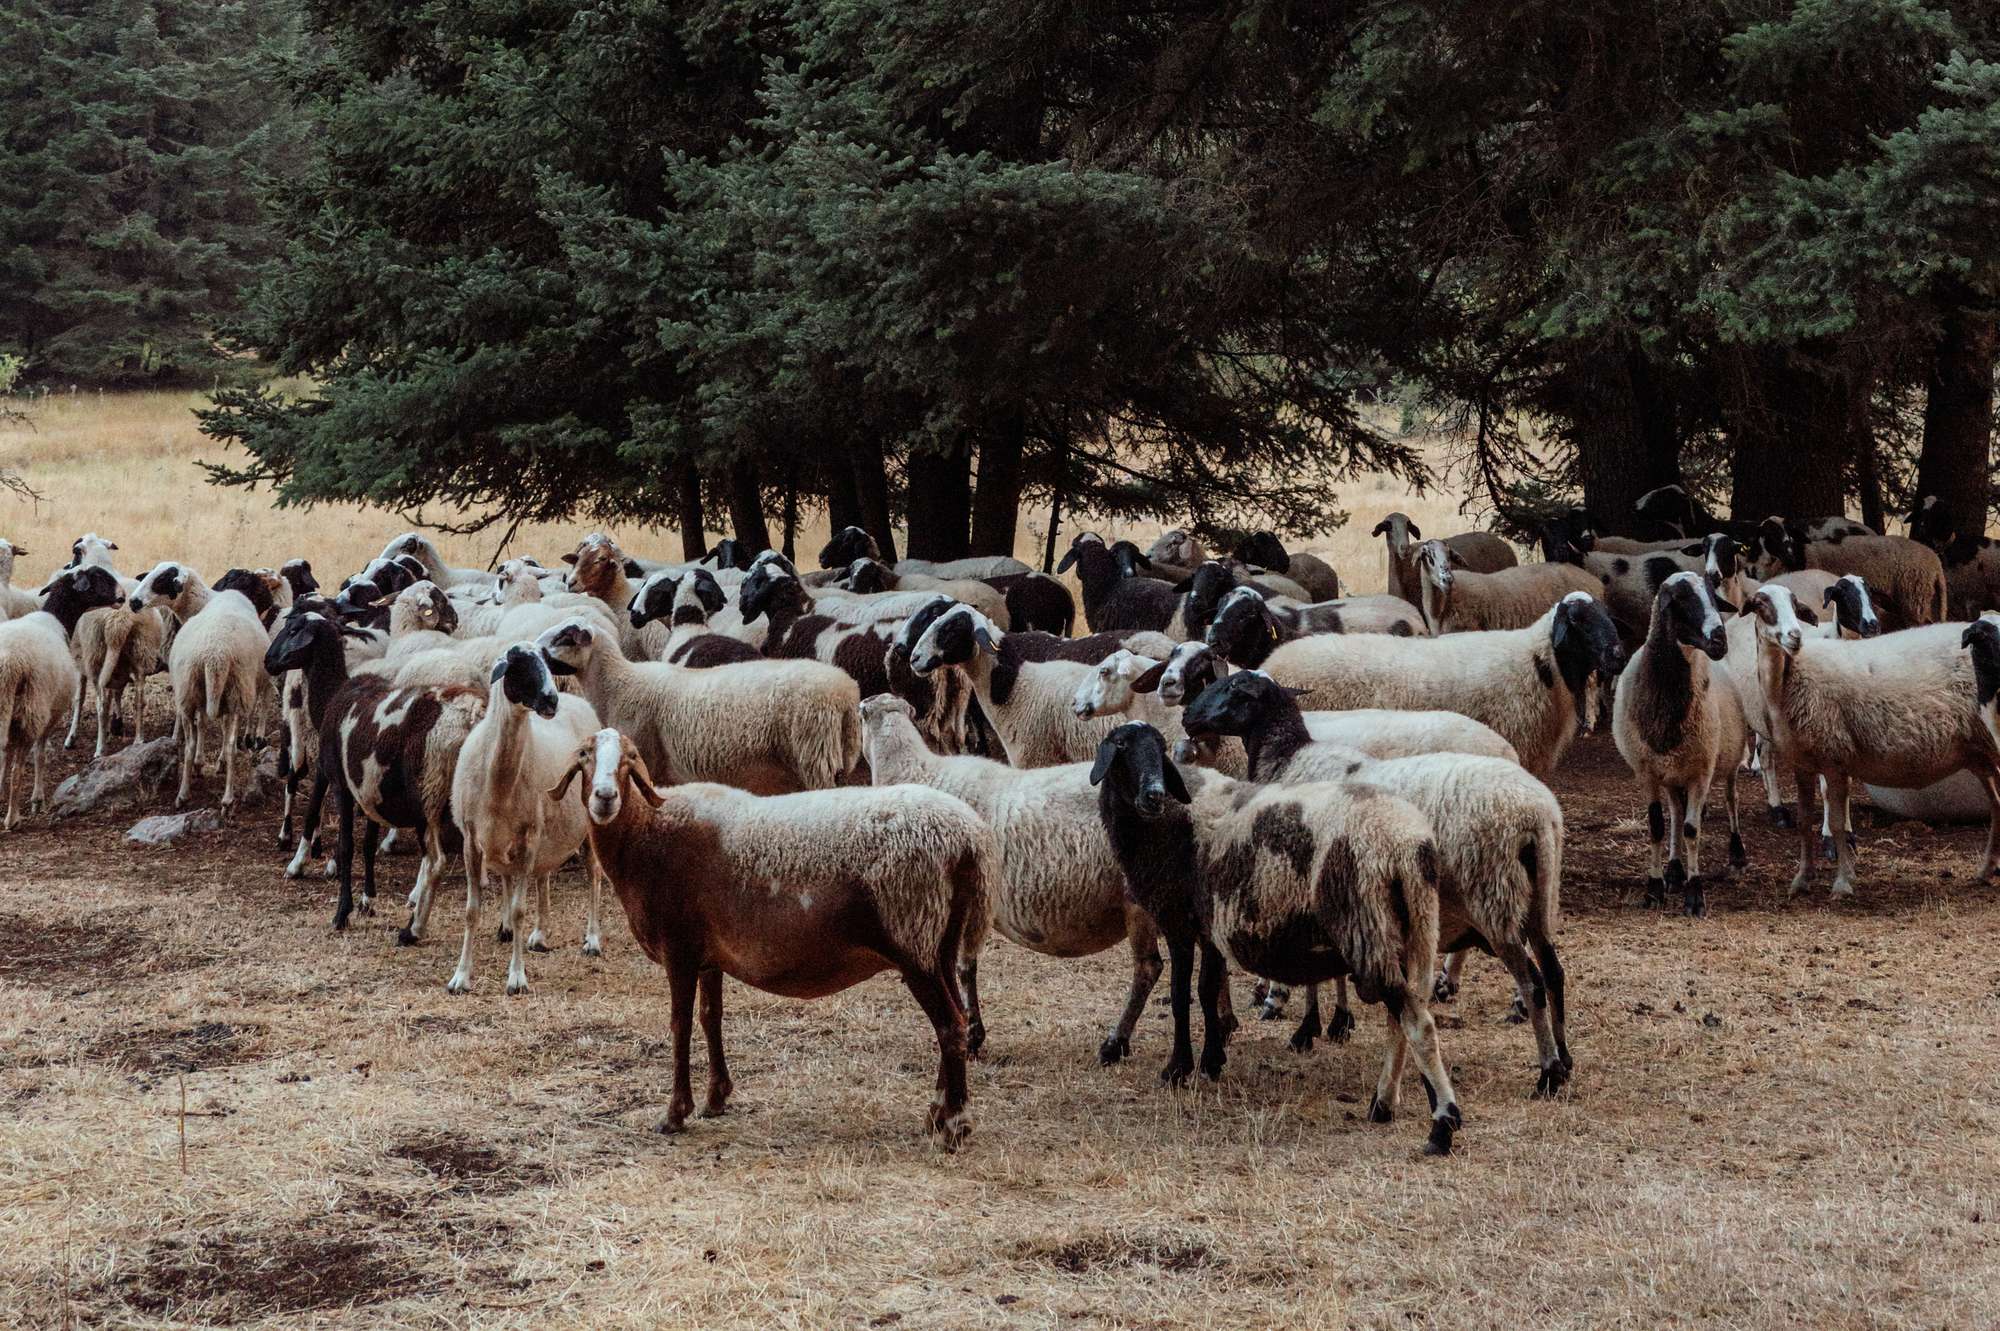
[0, 0, 2000, 558]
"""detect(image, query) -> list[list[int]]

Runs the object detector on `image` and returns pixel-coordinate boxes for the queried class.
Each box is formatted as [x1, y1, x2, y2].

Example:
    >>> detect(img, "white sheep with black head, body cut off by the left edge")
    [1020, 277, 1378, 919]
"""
[0, 566, 122, 831]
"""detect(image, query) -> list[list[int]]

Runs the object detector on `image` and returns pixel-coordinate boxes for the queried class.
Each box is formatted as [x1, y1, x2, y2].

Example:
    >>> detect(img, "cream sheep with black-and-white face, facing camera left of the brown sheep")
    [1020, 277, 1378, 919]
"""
[410, 644, 604, 995]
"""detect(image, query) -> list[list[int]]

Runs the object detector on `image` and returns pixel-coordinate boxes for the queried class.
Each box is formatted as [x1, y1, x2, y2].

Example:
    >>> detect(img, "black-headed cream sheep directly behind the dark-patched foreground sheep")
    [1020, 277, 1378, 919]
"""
[1186, 671, 1574, 1095]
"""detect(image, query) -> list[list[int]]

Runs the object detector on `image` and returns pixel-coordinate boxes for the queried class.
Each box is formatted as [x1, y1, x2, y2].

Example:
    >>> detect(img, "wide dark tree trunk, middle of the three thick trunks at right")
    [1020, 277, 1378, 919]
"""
[1724, 348, 1866, 522]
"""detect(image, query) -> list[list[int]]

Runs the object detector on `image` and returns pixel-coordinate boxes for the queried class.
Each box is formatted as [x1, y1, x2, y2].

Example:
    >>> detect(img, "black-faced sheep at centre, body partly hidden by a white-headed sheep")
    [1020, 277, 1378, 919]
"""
[910, 606, 1174, 767]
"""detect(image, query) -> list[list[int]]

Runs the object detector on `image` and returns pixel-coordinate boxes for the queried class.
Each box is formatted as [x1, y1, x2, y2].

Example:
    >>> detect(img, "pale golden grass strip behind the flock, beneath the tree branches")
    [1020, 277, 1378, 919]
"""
[0, 392, 1466, 592]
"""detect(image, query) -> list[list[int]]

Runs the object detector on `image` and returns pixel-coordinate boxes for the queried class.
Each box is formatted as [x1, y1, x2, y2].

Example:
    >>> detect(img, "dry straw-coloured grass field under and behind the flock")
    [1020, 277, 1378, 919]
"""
[0, 393, 2000, 1331]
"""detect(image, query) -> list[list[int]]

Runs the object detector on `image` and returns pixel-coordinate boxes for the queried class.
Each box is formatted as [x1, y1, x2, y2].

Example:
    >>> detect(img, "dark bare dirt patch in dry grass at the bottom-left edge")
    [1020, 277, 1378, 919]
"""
[114, 1221, 418, 1323]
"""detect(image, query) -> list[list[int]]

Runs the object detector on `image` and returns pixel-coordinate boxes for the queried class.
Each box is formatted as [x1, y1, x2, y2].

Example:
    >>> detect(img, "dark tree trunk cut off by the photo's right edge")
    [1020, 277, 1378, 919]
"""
[1916, 308, 2000, 536]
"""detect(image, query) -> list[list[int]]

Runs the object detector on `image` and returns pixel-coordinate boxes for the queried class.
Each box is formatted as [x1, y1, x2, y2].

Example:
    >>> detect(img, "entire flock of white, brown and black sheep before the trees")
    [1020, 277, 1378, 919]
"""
[0, 479, 2000, 1153]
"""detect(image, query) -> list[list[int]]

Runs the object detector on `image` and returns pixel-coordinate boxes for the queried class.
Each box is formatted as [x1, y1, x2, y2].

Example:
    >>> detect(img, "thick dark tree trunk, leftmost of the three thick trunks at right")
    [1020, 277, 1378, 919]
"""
[1568, 344, 1680, 532]
